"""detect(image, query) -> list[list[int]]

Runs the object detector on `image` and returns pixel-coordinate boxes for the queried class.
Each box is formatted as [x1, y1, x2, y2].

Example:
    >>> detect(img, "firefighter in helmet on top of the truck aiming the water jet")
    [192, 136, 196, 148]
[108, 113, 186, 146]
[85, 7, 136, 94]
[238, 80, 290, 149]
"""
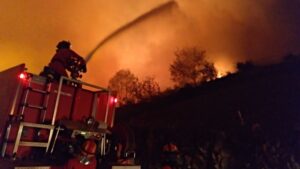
[41, 40, 86, 81]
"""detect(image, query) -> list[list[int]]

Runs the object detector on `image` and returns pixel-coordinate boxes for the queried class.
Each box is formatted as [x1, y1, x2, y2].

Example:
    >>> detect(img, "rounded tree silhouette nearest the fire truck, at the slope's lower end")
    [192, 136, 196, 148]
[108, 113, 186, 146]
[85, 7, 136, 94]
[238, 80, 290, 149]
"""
[108, 69, 139, 105]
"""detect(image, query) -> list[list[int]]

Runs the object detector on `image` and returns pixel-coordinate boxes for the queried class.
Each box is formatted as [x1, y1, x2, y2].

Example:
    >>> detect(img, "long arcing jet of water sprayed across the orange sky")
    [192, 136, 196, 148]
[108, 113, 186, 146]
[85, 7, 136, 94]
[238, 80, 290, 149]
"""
[85, 0, 177, 62]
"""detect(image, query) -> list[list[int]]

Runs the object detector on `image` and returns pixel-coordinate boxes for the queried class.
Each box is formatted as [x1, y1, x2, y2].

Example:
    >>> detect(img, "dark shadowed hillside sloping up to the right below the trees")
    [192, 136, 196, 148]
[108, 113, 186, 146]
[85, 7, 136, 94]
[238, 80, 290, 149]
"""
[116, 56, 300, 169]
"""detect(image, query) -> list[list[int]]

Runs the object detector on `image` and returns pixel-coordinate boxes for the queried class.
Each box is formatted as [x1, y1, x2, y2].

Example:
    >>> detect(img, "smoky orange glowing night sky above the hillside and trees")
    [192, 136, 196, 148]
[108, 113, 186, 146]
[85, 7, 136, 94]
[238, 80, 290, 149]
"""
[0, 0, 300, 88]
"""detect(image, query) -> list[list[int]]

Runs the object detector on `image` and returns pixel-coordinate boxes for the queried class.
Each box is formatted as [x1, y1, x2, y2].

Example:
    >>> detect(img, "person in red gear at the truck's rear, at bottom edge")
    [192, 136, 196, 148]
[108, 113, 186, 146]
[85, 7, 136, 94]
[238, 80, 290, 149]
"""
[65, 139, 97, 169]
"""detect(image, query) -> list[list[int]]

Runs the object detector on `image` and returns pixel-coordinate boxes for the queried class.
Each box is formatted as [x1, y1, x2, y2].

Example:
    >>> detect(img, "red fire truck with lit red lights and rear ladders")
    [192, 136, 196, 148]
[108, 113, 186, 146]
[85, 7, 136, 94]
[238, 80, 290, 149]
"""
[0, 64, 120, 169]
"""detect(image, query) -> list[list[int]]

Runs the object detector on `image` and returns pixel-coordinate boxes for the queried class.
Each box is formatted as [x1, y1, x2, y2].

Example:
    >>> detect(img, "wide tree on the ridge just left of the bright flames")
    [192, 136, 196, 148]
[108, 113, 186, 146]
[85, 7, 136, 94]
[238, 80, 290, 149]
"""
[170, 47, 217, 87]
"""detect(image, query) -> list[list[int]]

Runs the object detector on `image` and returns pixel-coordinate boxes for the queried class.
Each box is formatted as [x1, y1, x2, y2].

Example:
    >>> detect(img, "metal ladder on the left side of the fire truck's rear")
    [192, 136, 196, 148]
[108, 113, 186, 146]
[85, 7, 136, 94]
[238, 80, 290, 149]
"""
[13, 75, 55, 156]
